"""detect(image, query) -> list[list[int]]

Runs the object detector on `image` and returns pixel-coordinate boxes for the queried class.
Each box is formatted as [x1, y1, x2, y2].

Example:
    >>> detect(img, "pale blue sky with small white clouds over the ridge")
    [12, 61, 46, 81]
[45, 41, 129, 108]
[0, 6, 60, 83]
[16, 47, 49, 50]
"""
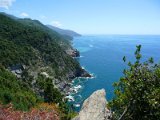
[0, 0, 160, 35]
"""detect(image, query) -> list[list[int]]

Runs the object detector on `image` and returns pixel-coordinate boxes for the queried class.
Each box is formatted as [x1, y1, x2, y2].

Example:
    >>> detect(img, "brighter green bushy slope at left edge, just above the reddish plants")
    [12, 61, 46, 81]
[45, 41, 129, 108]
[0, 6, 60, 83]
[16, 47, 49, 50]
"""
[0, 65, 41, 110]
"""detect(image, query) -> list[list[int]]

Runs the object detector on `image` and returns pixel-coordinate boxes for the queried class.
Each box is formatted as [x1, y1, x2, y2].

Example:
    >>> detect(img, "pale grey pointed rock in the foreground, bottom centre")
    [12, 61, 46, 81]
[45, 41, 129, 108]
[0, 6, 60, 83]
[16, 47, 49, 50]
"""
[73, 89, 111, 120]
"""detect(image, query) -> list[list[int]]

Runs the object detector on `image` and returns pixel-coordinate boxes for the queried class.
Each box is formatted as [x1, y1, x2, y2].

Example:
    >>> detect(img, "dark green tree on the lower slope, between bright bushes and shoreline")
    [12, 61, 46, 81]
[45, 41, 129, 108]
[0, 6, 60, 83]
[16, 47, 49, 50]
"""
[36, 75, 75, 120]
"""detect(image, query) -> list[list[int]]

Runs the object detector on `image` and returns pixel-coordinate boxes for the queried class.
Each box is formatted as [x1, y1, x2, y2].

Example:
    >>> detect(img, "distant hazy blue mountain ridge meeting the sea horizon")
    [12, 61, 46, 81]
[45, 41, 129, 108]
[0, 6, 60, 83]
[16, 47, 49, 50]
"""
[47, 25, 81, 37]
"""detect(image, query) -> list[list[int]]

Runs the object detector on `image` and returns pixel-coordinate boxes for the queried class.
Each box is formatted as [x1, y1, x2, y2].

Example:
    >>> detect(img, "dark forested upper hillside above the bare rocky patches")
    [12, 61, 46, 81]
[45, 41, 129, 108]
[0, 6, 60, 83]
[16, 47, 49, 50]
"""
[0, 11, 80, 76]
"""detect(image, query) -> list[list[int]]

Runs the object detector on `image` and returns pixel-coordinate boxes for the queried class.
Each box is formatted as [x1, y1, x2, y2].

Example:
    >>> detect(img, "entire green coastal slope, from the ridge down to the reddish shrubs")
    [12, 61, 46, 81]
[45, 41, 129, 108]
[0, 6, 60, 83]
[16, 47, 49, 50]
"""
[0, 13, 82, 120]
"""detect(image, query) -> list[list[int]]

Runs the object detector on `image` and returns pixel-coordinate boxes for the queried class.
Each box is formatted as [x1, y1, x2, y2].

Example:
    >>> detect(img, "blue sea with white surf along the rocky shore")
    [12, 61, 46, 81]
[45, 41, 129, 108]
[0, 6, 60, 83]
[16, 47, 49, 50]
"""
[71, 35, 160, 111]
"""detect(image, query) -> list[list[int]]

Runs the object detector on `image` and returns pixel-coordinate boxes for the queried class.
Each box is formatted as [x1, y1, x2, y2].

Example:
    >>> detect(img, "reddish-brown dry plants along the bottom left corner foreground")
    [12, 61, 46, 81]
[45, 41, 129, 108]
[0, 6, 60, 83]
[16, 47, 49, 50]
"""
[0, 103, 60, 120]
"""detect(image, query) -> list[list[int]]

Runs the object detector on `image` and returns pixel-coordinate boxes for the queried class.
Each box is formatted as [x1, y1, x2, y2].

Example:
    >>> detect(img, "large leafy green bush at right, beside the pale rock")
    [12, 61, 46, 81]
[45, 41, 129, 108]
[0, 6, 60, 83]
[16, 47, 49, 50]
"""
[109, 45, 160, 120]
